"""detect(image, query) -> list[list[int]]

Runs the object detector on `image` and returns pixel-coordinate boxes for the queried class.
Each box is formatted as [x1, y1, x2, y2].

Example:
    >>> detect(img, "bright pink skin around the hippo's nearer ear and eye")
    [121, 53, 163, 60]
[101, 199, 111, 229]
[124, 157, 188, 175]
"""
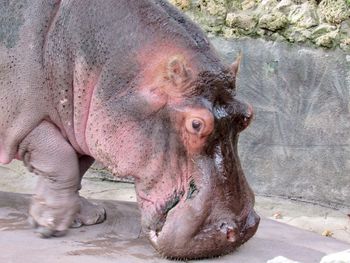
[137, 43, 214, 156]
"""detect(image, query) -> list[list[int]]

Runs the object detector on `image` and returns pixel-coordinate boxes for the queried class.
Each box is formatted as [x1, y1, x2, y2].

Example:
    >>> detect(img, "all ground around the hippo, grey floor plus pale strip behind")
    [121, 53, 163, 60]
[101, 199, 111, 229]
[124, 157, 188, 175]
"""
[0, 163, 350, 263]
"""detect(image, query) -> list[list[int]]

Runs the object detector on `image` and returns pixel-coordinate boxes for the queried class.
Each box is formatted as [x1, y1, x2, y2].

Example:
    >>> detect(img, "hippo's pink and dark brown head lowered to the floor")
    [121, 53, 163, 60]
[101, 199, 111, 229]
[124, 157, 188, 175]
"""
[86, 48, 259, 259]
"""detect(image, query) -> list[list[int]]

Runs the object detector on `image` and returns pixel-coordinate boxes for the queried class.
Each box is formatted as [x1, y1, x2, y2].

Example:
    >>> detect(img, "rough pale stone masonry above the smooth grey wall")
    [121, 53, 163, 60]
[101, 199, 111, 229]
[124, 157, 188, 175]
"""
[170, 0, 350, 51]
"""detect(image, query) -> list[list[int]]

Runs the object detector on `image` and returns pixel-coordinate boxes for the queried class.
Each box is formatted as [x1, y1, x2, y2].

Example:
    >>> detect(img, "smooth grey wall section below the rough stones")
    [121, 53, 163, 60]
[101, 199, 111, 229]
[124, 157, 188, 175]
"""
[212, 38, 350, 210]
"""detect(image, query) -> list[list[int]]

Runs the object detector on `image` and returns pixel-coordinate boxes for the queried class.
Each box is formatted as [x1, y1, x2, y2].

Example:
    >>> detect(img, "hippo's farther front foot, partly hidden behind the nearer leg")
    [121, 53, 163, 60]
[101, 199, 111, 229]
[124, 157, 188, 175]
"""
[70, 197, 106, 228]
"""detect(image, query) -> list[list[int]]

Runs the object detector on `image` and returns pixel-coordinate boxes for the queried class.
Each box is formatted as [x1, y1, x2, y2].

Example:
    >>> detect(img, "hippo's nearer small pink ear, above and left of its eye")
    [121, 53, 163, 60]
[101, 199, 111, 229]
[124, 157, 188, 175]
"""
[166, 56, 192, 86]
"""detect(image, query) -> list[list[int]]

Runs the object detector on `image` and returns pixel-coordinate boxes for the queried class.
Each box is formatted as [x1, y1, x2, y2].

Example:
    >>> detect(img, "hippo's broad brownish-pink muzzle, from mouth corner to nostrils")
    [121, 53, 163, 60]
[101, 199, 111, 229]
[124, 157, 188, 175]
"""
[139, 146, 260, 259]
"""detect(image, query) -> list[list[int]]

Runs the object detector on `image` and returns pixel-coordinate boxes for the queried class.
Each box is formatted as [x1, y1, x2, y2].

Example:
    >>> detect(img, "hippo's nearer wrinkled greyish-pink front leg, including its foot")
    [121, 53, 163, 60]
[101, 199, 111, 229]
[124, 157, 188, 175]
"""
[19, 121, 104, 237]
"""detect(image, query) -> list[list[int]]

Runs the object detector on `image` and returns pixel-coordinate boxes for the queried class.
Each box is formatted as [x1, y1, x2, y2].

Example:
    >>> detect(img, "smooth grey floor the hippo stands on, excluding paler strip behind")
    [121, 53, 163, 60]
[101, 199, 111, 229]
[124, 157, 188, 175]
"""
[0, 192, 350, 263]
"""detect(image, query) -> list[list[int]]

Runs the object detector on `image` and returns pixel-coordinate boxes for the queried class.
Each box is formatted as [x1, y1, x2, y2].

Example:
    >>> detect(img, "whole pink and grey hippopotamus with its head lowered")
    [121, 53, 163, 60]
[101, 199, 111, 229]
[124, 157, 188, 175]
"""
[0, 0, 259, 259]
